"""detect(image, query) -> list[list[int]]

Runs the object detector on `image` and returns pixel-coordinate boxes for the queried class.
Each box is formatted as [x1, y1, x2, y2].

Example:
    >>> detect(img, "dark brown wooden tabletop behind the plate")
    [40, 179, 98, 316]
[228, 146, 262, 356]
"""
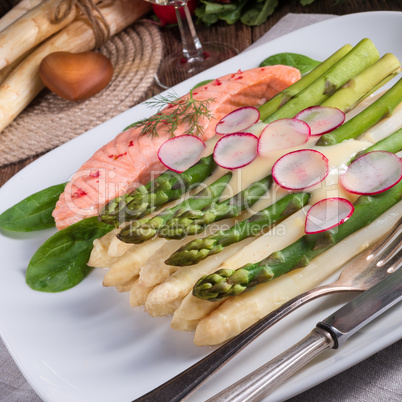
[0, 0, 402, 186]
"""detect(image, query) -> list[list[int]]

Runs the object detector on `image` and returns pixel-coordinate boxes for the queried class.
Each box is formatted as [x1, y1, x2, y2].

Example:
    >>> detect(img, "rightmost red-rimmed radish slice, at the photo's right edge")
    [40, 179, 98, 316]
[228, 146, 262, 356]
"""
[340, 151, 402, 195]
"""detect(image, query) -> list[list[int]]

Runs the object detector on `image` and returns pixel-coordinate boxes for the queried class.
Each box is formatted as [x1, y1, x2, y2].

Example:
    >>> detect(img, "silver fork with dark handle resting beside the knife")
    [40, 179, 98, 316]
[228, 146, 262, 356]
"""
[135, 218, 402, 402]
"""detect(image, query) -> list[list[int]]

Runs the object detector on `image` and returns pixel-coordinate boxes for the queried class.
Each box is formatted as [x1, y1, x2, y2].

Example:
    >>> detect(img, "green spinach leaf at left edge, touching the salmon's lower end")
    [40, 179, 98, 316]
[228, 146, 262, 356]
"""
[0, 183, 66, 232]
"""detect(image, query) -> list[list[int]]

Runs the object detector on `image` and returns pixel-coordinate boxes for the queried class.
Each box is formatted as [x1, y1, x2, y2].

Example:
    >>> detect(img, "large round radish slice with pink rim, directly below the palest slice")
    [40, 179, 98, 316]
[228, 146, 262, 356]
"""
[272, 149, 328, 190]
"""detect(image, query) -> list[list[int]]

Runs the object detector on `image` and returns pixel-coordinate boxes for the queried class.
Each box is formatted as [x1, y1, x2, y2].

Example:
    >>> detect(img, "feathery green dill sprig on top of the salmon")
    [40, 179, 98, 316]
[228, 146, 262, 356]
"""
[125, 90, 215, 137]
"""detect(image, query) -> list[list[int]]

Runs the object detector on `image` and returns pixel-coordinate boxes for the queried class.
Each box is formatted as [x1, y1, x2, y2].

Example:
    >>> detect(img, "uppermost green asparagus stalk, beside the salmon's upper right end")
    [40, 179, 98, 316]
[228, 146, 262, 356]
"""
[258, 45, 353, 120]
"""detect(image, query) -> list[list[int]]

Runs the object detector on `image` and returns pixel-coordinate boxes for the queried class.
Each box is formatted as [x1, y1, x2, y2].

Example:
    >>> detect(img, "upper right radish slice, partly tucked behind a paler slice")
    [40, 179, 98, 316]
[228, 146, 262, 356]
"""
[295, 106, 345, 135]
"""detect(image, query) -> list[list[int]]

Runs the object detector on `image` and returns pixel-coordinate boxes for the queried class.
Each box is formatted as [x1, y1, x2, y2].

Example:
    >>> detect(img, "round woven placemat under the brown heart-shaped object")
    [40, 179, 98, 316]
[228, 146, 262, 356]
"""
[0, 21, 162, 166]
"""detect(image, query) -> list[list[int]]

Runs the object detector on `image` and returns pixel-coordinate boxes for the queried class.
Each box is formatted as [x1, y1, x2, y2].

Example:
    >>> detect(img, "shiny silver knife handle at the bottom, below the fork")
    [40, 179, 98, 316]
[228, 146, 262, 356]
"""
[207, 328, 334, 402]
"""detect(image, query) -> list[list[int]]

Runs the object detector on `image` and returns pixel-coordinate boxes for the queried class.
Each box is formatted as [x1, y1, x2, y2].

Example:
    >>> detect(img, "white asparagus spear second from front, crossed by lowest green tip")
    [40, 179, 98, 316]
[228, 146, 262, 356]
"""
[171, 207, 309, 331]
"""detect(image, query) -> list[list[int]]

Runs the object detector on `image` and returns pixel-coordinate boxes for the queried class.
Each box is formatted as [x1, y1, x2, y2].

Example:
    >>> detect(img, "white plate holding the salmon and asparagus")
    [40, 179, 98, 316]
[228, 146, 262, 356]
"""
[0, 12, 402, 402]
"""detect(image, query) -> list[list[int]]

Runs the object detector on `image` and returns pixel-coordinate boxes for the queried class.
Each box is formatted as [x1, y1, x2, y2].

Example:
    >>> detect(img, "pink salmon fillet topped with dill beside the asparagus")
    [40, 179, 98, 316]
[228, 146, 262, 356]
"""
[53, 65, 300, 230]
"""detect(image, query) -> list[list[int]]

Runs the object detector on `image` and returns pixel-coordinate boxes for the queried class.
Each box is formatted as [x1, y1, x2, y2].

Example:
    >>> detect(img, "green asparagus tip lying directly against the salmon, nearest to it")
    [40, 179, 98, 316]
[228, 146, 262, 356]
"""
[99, 155, 216, 225]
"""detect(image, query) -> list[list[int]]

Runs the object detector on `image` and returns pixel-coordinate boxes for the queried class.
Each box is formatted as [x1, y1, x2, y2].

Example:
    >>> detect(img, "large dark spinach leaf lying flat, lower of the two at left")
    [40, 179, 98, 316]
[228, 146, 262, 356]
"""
[26, 216, 114, 292]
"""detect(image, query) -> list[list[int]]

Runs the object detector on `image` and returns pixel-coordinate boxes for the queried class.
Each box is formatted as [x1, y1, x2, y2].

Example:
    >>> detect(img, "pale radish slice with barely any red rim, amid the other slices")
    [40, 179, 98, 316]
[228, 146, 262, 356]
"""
[258, 119, 311, 156]
